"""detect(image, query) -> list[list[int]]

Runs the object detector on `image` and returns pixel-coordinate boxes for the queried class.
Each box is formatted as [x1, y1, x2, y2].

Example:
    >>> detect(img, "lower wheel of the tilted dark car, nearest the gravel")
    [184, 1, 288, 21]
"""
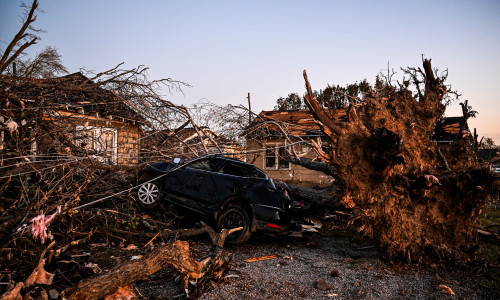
[217, 205, 252, 244]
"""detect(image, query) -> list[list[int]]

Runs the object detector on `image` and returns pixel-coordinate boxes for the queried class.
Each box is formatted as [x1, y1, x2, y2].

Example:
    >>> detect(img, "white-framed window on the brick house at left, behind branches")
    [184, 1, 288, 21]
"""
[75, 126, 118, 165]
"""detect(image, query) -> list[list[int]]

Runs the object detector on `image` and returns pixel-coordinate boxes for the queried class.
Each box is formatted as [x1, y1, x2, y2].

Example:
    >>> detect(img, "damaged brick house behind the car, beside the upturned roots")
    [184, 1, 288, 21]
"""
[245, 109, 346, 187]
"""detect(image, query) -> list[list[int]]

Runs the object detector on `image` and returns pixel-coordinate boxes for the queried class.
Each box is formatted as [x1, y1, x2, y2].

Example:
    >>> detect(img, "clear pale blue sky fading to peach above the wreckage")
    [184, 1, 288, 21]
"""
[0, 0, 500, 145]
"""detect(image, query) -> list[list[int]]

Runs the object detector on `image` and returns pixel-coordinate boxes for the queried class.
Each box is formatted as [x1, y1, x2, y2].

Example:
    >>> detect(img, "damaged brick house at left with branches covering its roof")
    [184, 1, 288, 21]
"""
[0, 73, 147, 164]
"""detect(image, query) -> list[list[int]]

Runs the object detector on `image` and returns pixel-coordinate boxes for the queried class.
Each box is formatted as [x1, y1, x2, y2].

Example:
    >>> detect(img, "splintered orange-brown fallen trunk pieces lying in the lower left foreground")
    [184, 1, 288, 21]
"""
[0, 224, 241, 300]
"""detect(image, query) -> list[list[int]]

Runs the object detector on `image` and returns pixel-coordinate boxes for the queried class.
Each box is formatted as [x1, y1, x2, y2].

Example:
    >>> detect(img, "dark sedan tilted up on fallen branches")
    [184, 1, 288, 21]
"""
[137, 155, 311, 244]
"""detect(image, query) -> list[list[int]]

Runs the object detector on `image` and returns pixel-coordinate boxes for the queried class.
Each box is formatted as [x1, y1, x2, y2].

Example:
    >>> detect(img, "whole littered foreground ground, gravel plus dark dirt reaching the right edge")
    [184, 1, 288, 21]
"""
[136, 221, 500, 299]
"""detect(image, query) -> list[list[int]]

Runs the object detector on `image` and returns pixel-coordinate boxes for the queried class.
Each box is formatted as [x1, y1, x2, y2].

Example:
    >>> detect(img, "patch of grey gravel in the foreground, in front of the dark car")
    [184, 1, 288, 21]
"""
[202, 237, 441, 299]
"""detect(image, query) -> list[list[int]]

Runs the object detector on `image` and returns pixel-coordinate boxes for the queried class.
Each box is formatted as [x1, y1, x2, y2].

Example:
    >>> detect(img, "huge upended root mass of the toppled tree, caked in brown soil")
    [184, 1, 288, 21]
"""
[304, 59, 491, 261]
